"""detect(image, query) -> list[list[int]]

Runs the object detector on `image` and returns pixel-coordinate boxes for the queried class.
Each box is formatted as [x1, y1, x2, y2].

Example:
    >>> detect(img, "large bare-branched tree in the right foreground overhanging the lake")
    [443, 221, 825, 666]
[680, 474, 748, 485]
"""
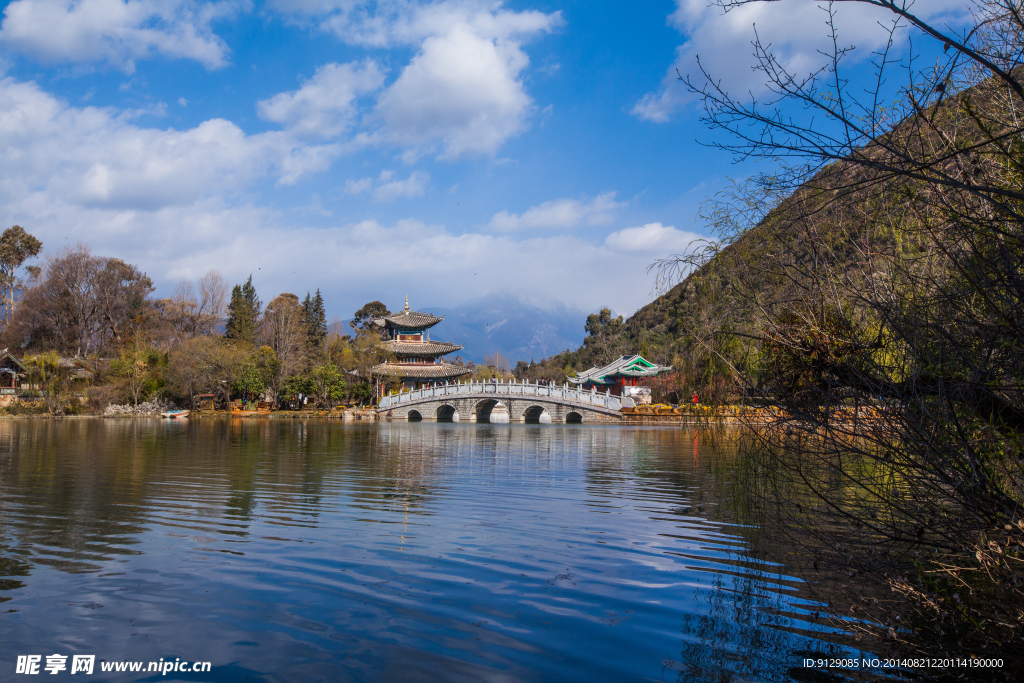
[656, 0, 1024, 655]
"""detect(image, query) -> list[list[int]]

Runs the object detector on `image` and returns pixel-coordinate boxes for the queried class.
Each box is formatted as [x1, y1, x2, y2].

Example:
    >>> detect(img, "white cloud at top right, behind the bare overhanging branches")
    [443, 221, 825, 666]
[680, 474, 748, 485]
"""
[633, 0, 968, 122]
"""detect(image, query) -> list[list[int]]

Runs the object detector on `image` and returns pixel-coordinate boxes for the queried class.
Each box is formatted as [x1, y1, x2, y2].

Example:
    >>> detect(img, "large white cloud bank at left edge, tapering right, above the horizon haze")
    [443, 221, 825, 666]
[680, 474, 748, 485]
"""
[0, 73, 338, 209]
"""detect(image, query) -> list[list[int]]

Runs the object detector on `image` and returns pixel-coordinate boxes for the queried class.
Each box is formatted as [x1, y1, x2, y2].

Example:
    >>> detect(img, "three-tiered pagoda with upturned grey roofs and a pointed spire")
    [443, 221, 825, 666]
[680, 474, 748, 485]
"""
[373, 296, 473, 391]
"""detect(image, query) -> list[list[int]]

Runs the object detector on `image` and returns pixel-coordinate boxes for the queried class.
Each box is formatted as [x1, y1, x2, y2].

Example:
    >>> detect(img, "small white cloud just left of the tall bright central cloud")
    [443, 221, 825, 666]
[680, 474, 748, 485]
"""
[257, 59, 384, 137]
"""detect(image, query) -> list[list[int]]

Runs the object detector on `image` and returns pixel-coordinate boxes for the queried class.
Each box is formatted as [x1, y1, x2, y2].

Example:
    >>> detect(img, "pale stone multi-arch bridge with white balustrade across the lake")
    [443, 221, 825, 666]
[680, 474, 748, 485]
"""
[377, 382, 634, 424]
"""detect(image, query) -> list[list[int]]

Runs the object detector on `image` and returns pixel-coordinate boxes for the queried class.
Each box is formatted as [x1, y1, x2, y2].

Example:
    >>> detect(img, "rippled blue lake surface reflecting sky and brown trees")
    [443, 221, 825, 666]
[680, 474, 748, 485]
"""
[0, 420, 872, 681]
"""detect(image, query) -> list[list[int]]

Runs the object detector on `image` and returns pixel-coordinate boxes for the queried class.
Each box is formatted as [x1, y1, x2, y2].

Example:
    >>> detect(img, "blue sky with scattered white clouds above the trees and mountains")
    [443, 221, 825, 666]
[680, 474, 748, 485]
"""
[0, 0, 965, 317]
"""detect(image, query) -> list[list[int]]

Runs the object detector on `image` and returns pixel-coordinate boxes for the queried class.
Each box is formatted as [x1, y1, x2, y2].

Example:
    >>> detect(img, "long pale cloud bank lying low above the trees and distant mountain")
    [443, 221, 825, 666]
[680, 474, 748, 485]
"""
[0, 194, 682, 316]
